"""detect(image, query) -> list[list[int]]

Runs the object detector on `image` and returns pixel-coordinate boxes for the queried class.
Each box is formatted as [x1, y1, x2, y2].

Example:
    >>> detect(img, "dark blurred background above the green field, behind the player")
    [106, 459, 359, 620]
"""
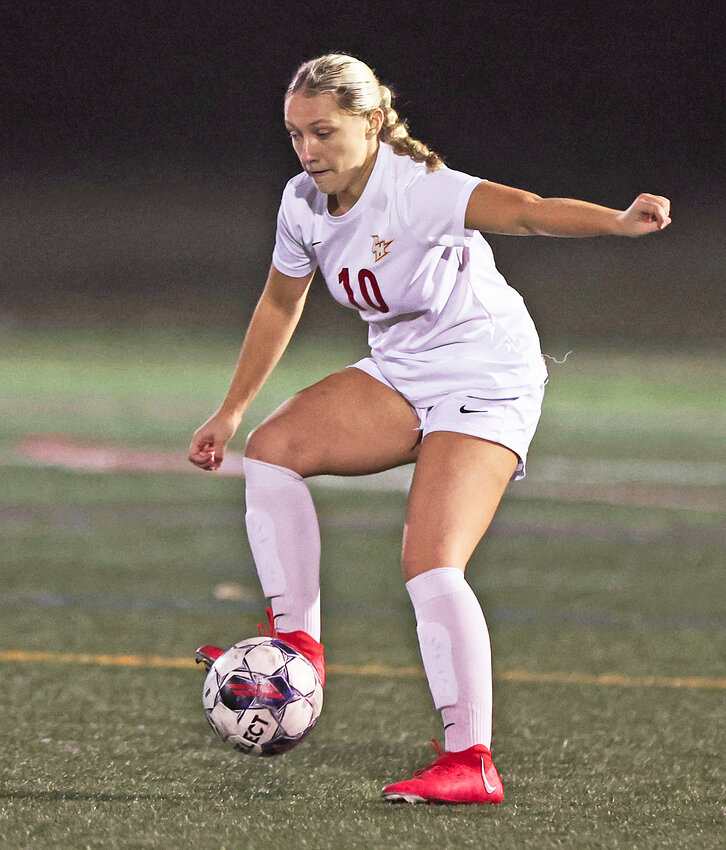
[0, 0, 726, 347]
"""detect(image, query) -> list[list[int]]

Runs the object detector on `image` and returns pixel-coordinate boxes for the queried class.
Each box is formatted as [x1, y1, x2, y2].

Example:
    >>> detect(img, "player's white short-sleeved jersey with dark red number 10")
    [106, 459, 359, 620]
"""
[272, 143, 547, 407]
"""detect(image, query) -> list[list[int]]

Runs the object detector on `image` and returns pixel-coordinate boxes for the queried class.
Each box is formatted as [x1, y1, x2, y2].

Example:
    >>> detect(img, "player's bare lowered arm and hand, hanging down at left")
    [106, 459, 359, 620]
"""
[189, 266, 313, 471]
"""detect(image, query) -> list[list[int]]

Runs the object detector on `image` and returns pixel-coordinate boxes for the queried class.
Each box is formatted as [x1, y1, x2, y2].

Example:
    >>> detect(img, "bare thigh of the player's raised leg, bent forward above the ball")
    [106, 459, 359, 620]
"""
[245, 368, 420, 477]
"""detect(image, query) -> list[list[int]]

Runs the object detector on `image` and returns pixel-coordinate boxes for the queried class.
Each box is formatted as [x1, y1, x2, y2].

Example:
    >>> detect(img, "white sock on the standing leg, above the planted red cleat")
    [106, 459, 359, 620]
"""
[406, 567, 492, 752]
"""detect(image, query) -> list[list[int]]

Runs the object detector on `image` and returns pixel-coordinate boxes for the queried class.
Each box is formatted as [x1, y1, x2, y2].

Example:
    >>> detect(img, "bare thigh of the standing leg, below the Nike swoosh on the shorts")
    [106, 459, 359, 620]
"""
[402, 431, 519, 580]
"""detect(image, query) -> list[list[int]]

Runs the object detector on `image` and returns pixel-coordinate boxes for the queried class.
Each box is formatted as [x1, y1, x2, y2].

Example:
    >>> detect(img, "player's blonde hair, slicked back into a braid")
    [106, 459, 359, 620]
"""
[286, 53, 444, 171]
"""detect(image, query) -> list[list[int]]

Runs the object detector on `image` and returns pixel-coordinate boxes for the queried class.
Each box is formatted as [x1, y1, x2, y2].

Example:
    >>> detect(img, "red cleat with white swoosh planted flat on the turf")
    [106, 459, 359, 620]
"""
[382, 741, 504, 803]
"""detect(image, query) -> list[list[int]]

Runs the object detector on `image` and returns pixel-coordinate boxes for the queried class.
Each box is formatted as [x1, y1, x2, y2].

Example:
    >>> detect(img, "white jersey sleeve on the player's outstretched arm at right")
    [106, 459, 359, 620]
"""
[403, 168, 482, 247]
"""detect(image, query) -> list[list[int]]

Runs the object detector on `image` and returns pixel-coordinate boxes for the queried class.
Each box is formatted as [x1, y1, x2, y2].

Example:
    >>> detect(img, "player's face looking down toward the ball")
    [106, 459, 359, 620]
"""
[285, 92, 380, 196]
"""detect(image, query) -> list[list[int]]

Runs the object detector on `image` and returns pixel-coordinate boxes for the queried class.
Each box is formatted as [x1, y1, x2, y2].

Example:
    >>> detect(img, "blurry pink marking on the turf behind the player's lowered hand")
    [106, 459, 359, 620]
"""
[18, 435, 243, 477]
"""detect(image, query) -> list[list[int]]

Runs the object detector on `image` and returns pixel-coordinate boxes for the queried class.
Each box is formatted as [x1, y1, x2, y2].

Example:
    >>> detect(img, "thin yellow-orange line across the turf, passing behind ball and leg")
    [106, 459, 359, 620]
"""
[0, 650, 726, 690]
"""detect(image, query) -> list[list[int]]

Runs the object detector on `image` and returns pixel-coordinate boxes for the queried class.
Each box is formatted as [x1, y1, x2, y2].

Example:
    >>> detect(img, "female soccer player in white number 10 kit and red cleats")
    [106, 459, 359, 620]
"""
[189, 54, 670, 803]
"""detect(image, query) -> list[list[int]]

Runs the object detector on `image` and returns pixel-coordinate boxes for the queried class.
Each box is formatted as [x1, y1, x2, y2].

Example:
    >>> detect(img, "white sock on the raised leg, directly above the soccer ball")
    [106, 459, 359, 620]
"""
[244, 457, 320, 641]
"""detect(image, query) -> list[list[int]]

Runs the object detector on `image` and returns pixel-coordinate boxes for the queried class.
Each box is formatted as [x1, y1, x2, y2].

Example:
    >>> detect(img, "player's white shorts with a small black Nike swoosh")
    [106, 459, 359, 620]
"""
[349, 357, 545, 481]
